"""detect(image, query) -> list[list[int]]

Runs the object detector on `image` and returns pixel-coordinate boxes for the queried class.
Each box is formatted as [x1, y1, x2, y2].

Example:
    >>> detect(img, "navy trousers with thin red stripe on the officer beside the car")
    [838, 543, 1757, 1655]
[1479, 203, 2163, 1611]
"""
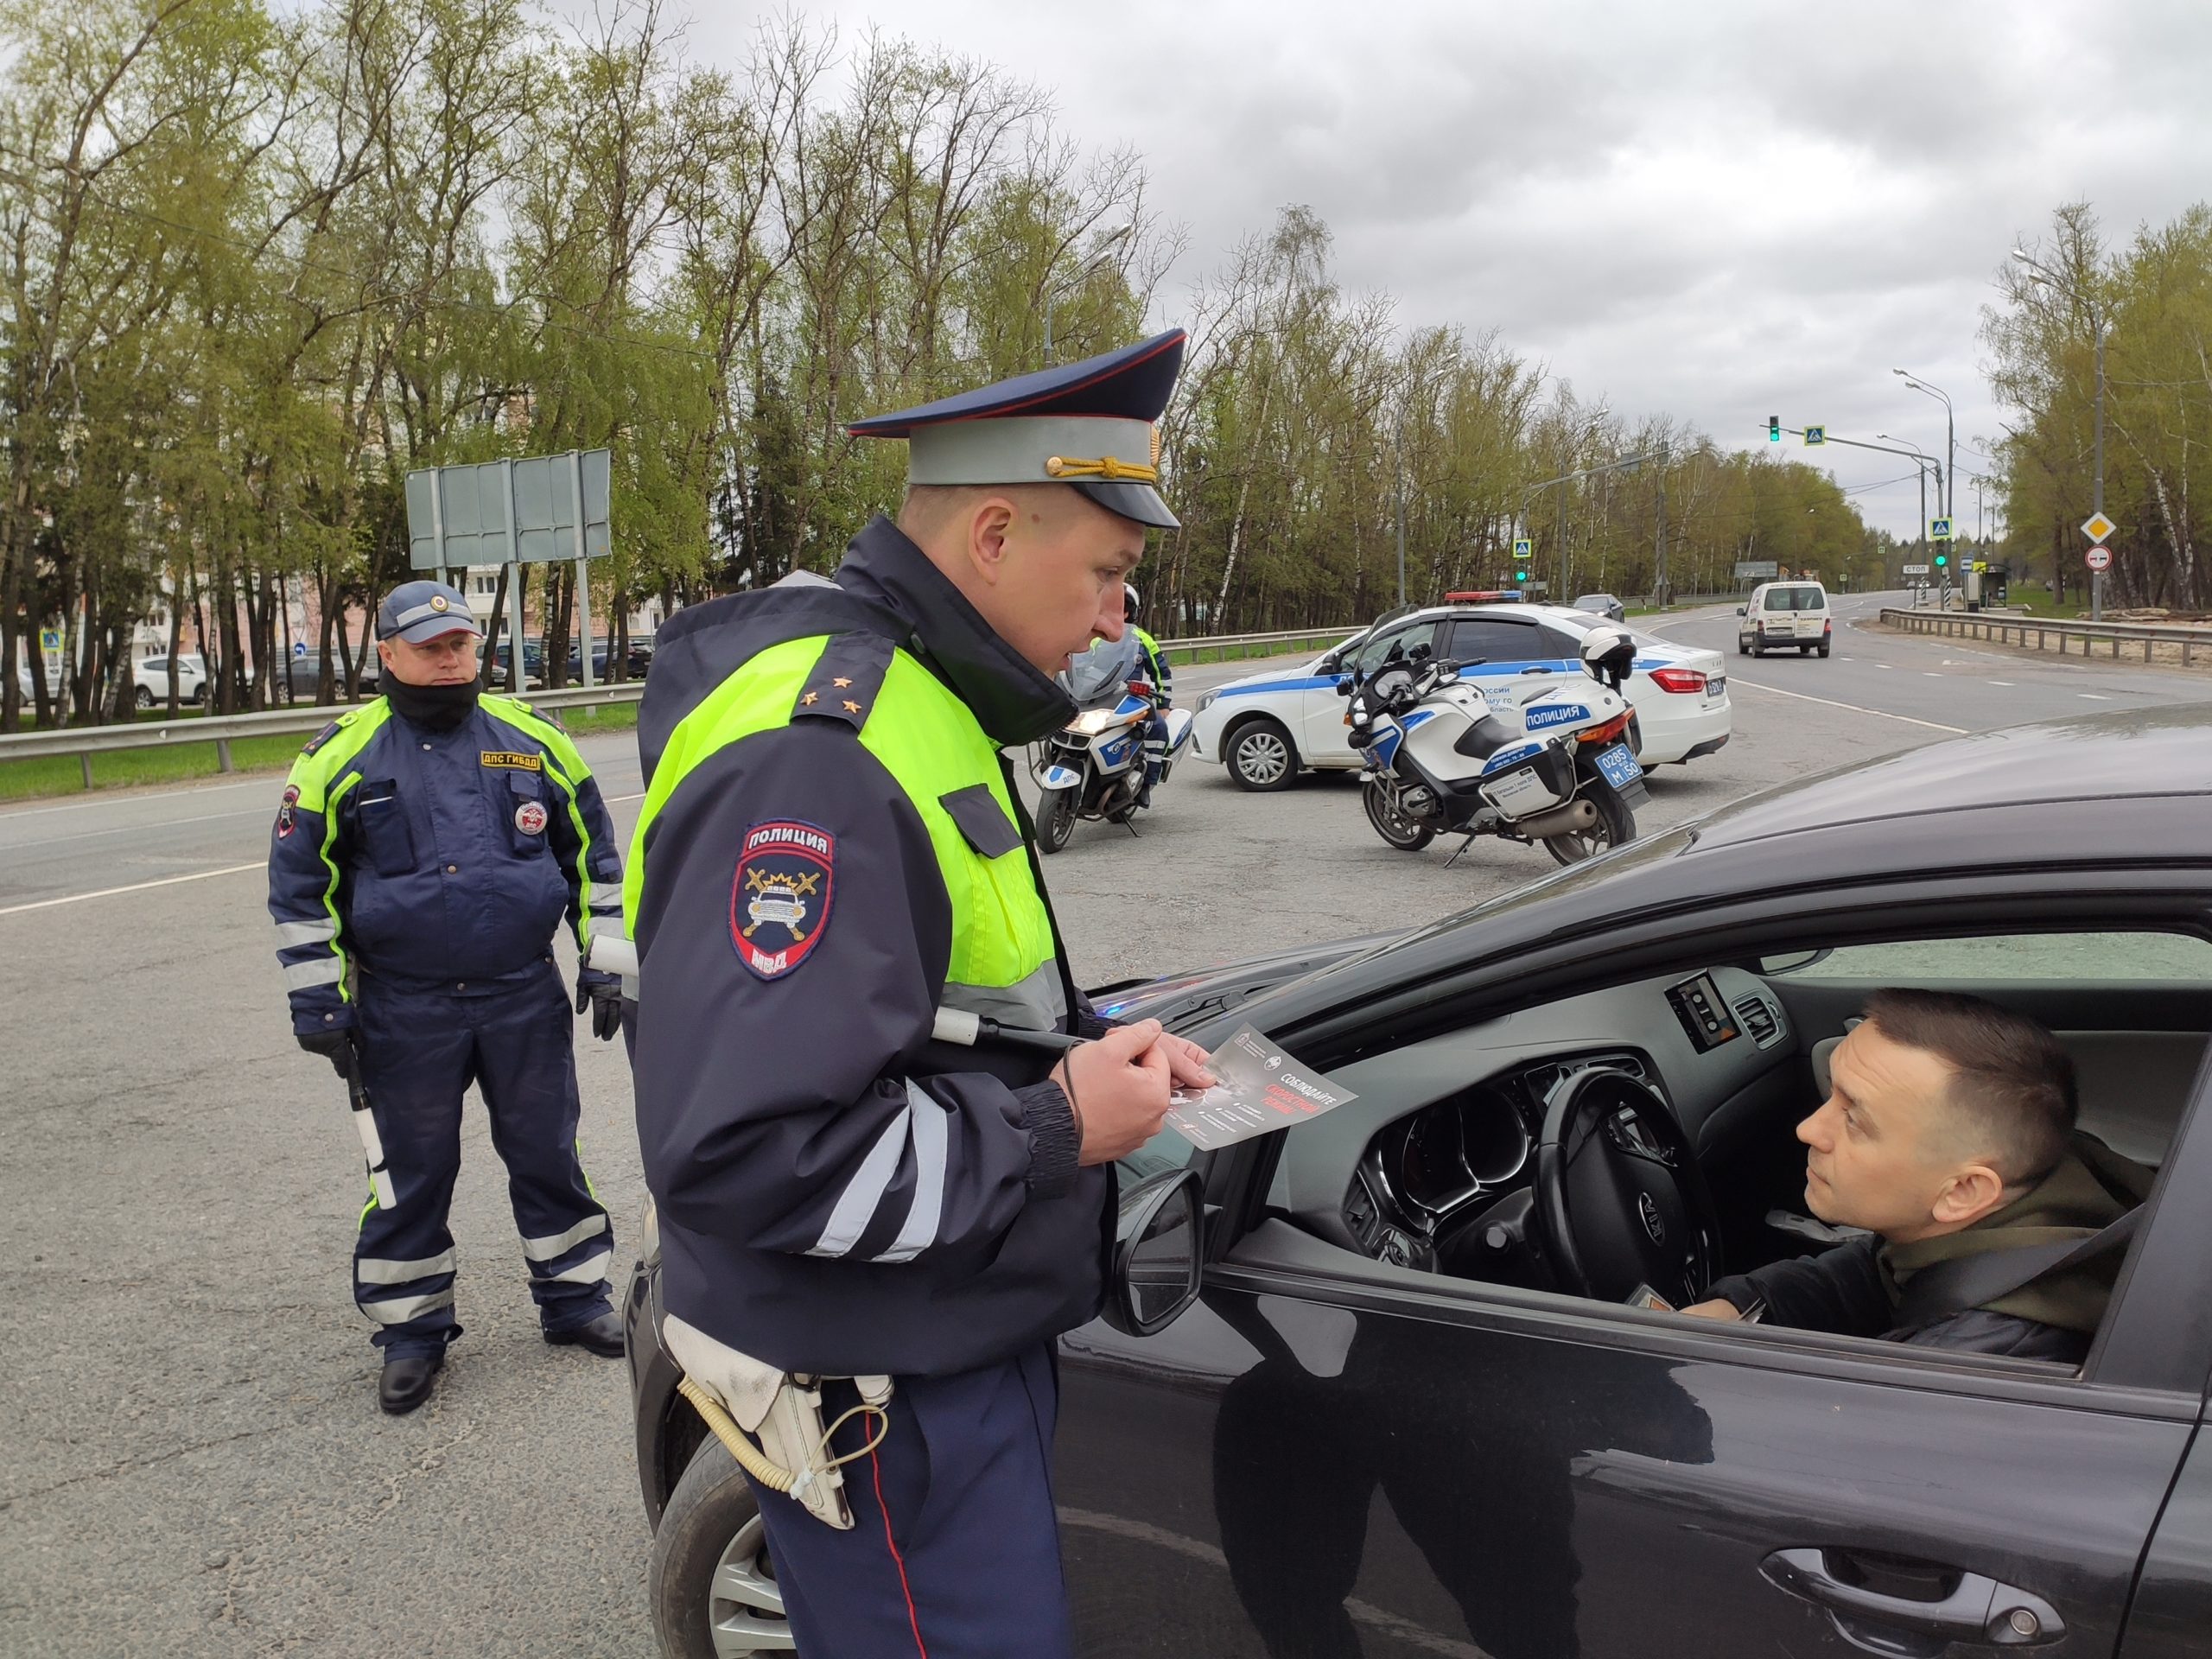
[752, 1343, 1073, 1659]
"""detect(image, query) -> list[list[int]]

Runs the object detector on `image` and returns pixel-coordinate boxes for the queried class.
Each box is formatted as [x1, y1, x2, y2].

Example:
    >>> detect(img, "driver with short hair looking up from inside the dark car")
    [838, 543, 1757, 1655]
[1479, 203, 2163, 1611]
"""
[1683, 991, 2148, 1365]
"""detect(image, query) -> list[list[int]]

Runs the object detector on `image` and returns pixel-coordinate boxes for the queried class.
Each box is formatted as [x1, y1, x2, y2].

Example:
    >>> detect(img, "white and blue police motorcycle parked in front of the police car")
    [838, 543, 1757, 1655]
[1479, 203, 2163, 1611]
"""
[1338, 628, 1650, 868]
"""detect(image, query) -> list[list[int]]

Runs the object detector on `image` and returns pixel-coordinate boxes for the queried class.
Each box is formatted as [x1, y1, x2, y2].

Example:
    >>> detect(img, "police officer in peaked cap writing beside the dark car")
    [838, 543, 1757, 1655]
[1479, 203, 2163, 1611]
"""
[626, 329, 1210, 1659]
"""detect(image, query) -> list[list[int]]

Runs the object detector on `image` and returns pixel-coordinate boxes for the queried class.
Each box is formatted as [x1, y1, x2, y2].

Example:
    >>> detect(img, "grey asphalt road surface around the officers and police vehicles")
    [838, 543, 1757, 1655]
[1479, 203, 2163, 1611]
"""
[0, 600, 2208, 1656]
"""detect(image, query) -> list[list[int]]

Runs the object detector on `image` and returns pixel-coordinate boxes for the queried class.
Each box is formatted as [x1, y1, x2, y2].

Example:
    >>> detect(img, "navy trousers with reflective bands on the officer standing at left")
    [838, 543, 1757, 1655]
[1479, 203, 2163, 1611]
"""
[354, 957, 615, 1358]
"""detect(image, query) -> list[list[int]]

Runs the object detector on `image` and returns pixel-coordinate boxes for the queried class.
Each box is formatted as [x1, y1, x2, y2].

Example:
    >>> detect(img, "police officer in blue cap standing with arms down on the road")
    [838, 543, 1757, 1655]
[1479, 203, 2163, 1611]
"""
[270, 582, 621, 1411]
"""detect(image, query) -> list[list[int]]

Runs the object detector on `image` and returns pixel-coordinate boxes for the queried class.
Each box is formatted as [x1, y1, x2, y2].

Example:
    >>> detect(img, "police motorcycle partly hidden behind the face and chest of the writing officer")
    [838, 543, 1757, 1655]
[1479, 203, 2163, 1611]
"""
[1031, 631, 1192, 852]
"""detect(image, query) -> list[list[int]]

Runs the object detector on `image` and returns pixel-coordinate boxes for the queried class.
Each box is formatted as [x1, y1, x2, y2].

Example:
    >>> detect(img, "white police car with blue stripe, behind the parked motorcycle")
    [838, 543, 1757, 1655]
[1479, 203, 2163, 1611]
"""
[1190, 604, 1734, 790]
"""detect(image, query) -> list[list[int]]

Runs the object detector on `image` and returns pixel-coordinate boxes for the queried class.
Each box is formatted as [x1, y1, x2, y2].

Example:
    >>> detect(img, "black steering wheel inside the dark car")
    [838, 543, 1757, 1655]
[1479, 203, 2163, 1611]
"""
[1535, 1066, 1721, 1307]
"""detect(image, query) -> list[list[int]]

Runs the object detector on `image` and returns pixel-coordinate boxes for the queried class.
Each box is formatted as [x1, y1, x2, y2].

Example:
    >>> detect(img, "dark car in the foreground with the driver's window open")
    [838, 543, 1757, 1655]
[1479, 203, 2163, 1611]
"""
[626, 708, 2212, 1659]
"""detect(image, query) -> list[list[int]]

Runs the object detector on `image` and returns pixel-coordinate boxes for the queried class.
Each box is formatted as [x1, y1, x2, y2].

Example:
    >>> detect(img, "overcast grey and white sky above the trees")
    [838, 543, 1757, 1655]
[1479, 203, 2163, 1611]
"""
[690, 0, 2212, 536]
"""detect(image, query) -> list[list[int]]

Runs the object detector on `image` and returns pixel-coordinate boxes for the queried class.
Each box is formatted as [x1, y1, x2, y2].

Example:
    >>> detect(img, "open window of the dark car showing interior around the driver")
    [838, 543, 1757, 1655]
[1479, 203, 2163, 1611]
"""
[1261, 929, 2212, 1376]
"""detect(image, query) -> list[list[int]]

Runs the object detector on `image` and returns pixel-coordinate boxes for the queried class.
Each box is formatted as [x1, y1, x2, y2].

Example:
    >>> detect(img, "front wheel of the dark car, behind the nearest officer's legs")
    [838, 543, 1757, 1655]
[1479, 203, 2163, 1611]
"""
[646, 1435, 797, 1659]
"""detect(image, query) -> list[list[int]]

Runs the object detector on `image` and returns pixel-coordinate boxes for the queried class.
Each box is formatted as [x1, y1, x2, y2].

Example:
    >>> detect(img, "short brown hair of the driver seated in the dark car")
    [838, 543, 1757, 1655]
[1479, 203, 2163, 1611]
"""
[1867, 988, 2079, 1188]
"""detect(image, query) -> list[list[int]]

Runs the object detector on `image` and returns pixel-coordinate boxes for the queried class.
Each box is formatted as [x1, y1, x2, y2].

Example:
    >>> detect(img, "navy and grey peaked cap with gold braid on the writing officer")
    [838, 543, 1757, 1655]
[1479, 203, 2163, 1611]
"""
[847, 327, 1188, 531]
